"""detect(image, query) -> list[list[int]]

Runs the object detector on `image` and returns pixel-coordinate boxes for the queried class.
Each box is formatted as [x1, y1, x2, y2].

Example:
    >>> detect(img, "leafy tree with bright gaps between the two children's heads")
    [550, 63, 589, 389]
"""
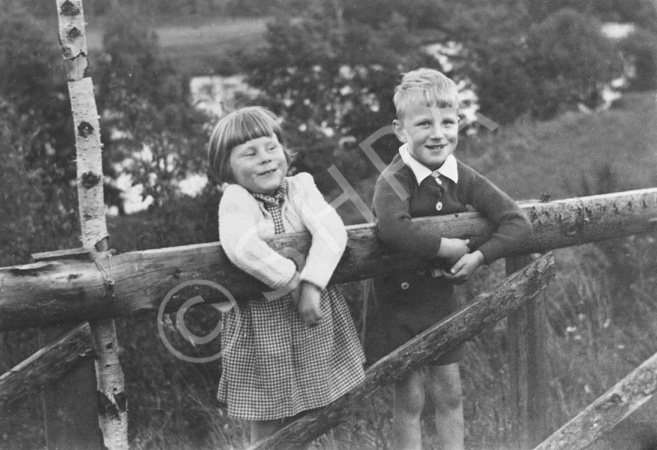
[244, 4, 437, 188]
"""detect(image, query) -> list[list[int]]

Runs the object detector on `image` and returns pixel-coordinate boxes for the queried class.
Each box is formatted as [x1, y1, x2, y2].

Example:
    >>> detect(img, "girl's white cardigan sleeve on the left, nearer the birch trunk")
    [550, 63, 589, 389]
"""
[219, 185, 296, 289]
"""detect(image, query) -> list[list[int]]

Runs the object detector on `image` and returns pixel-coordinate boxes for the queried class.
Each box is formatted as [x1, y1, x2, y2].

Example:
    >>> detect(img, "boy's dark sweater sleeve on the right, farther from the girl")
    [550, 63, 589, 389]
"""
[459, 164, 532, 264]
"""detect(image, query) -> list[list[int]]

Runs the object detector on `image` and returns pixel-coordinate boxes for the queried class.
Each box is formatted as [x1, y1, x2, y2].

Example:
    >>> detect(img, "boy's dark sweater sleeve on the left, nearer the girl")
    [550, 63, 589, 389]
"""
[373, 169, 442, 259]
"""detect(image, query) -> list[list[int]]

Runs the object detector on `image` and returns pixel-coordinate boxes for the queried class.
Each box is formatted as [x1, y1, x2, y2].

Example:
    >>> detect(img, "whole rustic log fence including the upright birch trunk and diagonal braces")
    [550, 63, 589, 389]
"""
[0, 0, 657, 450]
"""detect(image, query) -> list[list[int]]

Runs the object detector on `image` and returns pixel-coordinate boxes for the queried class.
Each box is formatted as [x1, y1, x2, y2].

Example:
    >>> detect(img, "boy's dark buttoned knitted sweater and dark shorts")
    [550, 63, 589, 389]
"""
[366, 155, 532, 364]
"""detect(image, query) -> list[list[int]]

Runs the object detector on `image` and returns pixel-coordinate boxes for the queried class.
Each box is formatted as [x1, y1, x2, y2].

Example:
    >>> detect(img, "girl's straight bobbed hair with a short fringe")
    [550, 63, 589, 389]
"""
[208, 106, 292, 183]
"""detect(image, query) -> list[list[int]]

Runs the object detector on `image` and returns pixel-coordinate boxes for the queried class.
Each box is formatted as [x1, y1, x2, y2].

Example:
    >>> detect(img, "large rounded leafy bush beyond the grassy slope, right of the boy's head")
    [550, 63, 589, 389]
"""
[463, 6, 622, 123]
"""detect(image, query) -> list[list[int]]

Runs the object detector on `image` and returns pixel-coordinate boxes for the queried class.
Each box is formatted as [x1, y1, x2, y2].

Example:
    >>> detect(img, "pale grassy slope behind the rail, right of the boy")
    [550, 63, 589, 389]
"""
[457, 92, 657, 199]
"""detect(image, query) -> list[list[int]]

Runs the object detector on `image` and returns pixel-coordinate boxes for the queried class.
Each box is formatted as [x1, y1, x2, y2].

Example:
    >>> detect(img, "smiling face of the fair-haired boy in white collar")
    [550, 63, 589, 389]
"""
[392, 102, 459, 170]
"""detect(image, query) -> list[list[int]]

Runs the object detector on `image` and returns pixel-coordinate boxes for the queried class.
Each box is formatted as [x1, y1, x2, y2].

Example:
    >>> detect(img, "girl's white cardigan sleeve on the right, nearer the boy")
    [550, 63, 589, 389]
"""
[290, 173, 347, 289]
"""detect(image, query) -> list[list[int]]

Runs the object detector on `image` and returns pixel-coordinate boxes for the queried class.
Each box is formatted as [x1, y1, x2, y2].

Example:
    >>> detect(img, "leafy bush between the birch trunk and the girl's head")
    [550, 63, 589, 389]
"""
[95, 9, 207, 206]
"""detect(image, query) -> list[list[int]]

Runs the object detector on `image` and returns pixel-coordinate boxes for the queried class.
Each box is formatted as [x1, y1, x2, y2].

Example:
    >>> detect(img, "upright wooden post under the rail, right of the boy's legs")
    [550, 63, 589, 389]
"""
[506, 255, 548, 450]
